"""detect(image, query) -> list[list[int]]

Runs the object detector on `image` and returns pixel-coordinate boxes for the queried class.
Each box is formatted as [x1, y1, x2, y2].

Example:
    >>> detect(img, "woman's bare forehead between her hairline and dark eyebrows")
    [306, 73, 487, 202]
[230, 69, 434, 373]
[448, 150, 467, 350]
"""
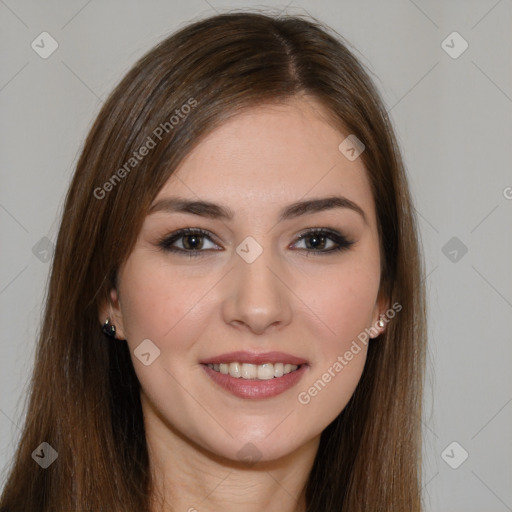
[155, 99, 374, 224]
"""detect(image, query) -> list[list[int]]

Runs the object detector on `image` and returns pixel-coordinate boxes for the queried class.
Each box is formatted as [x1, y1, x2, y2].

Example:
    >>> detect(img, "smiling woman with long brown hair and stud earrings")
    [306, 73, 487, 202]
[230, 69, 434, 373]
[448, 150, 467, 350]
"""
[0, 13, 426, 512]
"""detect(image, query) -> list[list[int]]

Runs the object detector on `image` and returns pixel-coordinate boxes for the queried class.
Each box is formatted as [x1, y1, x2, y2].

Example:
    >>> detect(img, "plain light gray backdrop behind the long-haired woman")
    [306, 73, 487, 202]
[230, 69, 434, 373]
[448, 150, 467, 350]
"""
[0, 0, 512, 512]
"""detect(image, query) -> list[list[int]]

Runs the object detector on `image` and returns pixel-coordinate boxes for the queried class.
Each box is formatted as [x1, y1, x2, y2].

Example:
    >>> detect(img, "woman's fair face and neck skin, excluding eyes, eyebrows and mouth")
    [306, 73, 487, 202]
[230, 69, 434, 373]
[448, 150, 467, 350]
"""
[100, 98, 388, 512]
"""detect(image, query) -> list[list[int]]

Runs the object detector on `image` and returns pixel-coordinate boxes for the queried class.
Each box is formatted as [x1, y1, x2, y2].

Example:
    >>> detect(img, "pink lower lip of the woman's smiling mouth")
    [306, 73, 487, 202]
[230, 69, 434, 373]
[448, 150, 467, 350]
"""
[202, 364, 308, 399]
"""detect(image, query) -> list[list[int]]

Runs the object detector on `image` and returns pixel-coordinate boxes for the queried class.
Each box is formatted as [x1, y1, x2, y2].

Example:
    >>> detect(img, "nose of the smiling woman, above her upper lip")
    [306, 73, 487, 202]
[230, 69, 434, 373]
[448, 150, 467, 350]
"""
[222, 245, 293, 334]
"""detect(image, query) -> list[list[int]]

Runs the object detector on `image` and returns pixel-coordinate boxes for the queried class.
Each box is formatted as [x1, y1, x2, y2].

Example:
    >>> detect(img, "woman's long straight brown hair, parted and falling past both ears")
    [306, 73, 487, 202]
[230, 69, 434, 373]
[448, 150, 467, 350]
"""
[0, 13, 426, 512]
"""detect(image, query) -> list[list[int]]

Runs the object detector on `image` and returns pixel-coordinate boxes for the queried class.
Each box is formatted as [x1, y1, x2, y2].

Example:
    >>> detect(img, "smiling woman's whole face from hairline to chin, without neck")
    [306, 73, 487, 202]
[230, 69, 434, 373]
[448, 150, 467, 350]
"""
[101, 99, 385, 460]
